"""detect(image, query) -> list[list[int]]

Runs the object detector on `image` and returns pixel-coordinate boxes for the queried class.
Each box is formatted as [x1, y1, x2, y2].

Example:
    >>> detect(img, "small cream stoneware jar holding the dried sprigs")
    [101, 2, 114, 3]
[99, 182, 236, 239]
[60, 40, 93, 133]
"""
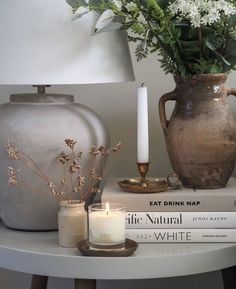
[58, 200, 87, 248]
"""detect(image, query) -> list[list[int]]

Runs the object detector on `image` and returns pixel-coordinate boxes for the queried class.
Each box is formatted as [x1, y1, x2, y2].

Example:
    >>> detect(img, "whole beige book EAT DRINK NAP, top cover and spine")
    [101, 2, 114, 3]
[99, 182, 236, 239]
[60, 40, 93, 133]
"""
[101, 178, 236, 212]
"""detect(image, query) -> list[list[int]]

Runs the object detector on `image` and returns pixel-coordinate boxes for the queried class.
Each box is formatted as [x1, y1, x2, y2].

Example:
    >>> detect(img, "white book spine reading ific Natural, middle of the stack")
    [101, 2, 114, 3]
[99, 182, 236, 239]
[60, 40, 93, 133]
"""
[126, 212, 236, 229]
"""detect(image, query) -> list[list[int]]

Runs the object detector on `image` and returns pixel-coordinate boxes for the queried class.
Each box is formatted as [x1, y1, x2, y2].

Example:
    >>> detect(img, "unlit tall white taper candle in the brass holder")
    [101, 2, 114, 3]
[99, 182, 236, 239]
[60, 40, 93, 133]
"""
[137, 84, 149, 164]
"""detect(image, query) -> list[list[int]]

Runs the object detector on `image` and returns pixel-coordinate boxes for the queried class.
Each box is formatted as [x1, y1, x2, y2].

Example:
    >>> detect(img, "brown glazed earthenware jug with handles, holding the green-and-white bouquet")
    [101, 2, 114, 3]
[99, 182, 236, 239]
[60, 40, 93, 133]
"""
[159, 74, 236, 189]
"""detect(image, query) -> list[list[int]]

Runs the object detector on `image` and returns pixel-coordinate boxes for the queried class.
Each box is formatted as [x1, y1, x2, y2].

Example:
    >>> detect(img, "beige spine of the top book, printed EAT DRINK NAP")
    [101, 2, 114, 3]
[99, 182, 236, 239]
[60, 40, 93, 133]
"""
[101, 192, 236, 212]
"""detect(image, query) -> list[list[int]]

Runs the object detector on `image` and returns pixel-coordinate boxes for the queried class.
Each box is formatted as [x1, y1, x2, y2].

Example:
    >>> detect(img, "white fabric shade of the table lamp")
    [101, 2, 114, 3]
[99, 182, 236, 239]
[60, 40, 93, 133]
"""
[0, 0, 134, 85]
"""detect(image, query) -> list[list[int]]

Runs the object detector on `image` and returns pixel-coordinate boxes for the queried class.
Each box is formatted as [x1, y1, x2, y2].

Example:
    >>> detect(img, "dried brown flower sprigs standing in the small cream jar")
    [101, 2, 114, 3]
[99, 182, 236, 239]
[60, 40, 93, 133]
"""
[7, 138, 121, 201]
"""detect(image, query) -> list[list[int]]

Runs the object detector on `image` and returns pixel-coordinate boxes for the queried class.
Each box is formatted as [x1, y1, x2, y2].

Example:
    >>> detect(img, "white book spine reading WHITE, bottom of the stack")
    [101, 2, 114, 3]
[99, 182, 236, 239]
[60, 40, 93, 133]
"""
[126, 229, 236, 243]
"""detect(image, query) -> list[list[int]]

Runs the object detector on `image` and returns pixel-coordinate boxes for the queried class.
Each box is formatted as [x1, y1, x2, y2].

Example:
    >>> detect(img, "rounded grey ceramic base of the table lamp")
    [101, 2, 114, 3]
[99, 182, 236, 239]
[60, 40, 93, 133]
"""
[0, 94, 109, 231]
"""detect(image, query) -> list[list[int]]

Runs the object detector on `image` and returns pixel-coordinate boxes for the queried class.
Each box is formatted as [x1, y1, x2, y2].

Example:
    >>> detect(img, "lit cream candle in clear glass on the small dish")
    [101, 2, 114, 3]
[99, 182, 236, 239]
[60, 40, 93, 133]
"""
[88, 203, 126, 250]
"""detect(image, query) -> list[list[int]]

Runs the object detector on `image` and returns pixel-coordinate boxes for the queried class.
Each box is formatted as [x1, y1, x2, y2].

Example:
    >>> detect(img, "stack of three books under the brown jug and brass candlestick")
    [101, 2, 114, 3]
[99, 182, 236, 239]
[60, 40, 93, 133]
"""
[101, 178, 236, 243]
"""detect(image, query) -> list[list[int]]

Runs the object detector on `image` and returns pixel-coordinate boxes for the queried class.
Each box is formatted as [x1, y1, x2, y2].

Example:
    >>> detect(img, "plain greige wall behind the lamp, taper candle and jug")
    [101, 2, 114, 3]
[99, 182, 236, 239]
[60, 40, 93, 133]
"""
[0, 47, 236, 176]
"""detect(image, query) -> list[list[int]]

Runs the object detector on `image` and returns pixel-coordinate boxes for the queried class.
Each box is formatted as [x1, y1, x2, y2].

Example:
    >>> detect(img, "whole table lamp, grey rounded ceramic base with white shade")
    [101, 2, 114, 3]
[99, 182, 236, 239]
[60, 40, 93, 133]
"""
[0, 0, 134, 230]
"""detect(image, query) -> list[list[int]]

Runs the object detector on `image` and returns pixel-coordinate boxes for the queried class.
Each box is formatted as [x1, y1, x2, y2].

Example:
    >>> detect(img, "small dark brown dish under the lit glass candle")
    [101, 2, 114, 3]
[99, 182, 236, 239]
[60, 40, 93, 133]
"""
[77, 239, 138, 257]
